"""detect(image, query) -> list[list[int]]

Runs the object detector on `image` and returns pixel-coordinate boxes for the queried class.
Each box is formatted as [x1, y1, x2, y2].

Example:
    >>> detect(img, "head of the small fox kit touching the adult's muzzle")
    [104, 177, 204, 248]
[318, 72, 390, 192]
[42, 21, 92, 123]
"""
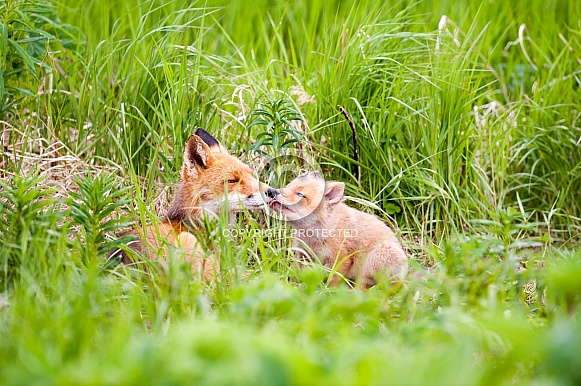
[266, 172, 345, 222]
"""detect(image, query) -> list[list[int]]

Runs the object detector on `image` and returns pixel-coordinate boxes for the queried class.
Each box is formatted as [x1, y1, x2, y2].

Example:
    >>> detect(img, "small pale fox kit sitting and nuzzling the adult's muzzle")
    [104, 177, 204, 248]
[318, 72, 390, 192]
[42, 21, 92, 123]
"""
[267, 172, 408, 289]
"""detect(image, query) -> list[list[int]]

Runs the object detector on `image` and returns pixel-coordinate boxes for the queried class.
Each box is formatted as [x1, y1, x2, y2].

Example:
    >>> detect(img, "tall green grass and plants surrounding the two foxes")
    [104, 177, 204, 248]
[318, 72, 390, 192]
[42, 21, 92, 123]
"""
[0, 0, 581, 385]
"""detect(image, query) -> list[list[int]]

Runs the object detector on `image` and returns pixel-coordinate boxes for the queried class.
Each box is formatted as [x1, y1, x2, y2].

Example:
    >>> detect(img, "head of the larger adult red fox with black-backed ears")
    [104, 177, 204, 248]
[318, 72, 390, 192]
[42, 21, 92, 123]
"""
[168, 129, 268, 220]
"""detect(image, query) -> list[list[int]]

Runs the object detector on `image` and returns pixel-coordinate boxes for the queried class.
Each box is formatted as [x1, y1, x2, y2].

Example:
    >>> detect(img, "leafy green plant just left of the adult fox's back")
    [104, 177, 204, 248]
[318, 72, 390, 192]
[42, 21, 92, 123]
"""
[70, 175, 133, 263]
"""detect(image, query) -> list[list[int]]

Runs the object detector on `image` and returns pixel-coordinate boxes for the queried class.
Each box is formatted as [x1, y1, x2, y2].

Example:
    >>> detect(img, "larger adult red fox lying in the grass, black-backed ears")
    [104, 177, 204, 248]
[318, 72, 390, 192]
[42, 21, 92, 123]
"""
[109, 128, 264, 279]
